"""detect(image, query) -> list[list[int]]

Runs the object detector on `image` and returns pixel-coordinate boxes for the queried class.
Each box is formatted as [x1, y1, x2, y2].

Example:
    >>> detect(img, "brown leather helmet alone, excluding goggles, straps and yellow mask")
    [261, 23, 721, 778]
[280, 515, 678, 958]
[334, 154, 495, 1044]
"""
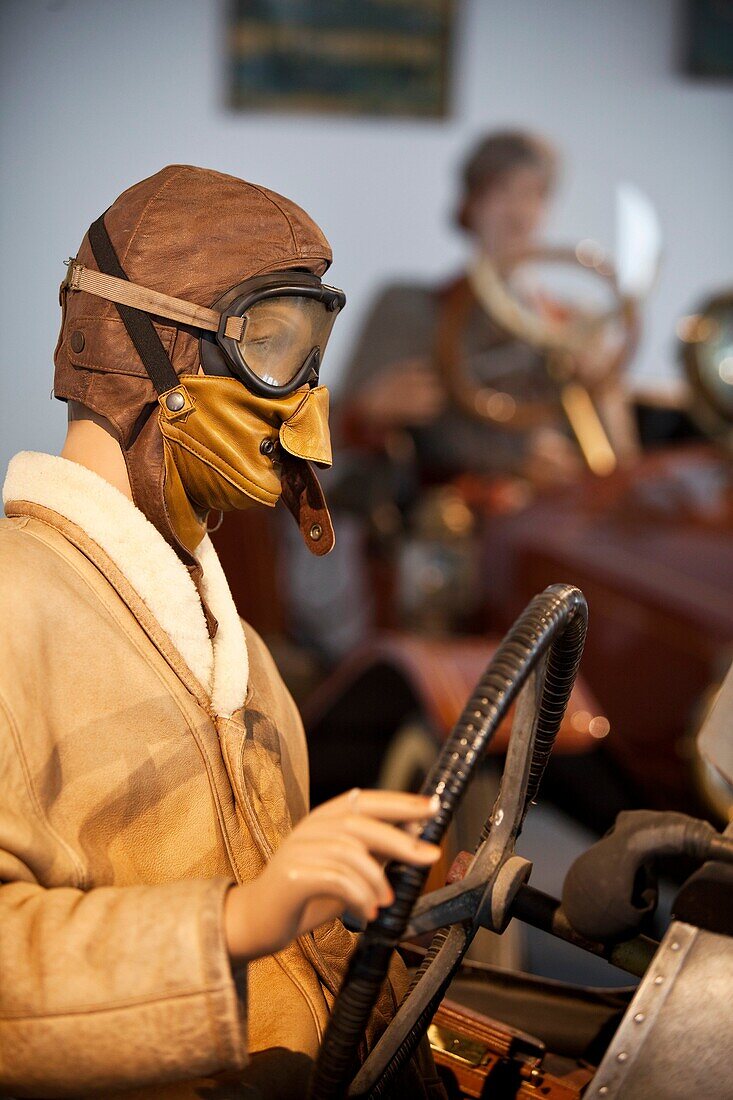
[54, 165, 331, 565]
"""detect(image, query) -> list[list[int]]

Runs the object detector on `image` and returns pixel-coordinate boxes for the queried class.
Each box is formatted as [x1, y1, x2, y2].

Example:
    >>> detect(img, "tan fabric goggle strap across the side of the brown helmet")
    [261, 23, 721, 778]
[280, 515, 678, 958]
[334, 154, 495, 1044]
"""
[63, 260, 244, 340]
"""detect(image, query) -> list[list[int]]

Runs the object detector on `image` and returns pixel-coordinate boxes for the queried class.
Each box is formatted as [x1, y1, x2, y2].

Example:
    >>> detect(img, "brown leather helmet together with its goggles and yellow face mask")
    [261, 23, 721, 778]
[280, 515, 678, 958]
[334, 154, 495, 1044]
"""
[54, 166, 344, 567]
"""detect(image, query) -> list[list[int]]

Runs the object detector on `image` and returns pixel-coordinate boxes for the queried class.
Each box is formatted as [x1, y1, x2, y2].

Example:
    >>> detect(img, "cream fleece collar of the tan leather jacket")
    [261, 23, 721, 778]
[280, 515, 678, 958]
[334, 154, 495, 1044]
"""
[2, 451, 249, 717]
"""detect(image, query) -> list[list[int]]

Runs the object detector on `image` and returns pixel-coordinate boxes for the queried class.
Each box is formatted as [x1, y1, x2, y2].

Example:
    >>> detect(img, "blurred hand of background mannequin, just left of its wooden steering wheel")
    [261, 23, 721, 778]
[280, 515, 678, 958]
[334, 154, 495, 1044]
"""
[352, 359, 446, 429]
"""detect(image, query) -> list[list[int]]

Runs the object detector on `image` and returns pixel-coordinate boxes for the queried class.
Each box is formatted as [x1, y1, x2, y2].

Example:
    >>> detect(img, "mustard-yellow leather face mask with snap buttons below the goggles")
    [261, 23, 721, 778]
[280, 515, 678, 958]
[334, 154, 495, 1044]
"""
[158, 374, 333, 554]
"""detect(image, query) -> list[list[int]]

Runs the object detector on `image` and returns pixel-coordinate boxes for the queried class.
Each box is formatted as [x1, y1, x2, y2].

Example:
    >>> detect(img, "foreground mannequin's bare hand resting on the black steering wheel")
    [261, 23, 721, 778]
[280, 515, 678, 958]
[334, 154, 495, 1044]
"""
[225, 789, 440, 963]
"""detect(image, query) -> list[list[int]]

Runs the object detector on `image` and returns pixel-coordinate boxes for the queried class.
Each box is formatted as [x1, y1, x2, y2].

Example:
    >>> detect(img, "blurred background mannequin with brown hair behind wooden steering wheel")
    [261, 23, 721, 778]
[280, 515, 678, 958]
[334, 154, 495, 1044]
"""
[341, 132, 592, 484]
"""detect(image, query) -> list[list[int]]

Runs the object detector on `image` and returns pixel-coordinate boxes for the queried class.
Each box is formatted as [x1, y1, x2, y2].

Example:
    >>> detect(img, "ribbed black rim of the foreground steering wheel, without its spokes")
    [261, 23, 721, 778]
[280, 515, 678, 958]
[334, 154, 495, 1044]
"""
[309, 584, 588, 1100]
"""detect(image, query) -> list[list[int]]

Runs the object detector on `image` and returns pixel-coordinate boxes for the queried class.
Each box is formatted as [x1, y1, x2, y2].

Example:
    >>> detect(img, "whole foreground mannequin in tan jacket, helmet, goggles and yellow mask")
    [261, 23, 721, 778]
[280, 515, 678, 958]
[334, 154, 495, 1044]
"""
[0, 165, 442, 1100]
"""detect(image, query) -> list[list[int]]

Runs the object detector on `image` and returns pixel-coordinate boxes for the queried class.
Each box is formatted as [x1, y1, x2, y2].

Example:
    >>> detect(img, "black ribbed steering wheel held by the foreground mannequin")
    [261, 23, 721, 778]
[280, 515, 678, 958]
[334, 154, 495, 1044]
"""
[309, 584, 588, 1100]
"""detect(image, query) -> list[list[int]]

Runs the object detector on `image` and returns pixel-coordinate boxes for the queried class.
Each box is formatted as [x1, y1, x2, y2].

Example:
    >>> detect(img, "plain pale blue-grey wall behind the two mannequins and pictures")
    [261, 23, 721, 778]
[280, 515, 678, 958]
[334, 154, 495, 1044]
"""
[0, 0, 733, 469]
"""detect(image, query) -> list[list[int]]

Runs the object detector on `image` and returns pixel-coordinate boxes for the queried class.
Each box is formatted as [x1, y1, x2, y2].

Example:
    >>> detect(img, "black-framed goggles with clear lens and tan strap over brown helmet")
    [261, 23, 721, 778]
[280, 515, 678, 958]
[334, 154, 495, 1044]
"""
[62, 259, 346, 397]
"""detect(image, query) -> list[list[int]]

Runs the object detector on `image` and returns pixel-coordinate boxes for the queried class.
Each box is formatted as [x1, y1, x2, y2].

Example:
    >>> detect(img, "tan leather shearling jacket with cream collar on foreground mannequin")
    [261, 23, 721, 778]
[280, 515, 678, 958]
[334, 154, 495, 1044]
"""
[0, 453, 405, 1098]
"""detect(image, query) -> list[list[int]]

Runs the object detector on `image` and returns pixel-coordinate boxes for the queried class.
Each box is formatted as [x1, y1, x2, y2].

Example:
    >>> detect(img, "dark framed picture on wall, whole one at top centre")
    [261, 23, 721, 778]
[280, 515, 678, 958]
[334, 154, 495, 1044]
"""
[228, 0, 453, 118]
